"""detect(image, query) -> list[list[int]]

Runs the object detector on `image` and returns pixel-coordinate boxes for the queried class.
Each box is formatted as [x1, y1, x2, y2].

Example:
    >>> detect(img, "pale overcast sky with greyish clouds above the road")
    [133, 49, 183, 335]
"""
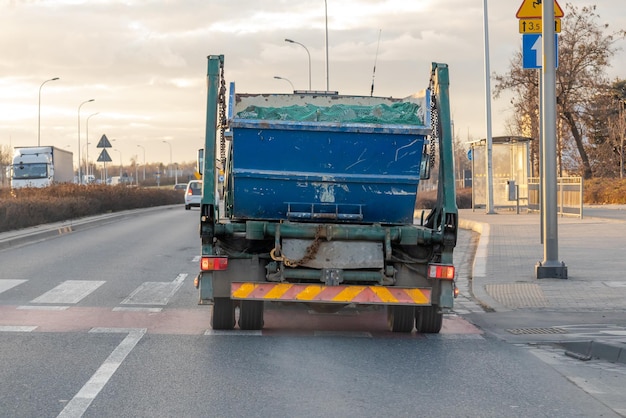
[0, 0, 626, 168]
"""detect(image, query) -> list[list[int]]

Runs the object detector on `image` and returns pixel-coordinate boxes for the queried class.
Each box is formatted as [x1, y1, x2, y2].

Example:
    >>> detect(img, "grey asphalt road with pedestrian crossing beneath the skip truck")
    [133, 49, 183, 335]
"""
[0, 205, 626, 417]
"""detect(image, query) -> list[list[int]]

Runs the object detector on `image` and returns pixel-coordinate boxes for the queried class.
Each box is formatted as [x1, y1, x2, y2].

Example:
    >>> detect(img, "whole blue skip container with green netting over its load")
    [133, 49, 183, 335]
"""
[229, 94, 430, 224]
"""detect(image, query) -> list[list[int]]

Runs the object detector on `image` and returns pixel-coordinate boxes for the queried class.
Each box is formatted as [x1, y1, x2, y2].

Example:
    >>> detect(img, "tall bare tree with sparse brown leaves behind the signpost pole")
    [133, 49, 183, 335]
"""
[494, 3, 626, 179]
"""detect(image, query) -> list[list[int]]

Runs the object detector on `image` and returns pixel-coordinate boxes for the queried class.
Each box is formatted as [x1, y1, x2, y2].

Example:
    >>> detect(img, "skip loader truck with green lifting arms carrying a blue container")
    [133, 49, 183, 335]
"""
[194, 55, 458, 333]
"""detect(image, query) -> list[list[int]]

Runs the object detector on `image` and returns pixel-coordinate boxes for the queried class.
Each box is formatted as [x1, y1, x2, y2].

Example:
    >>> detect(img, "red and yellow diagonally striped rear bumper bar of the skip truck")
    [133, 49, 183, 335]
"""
[230, 282, 431, 306]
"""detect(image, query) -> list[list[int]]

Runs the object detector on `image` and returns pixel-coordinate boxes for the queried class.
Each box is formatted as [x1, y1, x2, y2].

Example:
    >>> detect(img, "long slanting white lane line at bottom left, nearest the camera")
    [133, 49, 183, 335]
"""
[58, 328, 146, 418]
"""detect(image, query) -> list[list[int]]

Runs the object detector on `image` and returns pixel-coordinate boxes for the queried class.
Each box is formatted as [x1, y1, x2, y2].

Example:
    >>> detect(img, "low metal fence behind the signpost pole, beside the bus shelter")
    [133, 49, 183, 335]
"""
[528, 177, 584, 219]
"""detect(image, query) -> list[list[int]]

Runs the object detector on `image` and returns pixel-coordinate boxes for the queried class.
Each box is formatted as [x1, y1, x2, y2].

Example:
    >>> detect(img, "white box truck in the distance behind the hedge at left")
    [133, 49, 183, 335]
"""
[11, 146, 74, 189]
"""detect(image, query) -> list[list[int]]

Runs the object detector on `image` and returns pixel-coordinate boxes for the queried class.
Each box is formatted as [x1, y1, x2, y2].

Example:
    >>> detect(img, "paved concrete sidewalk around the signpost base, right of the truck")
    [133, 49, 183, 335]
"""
[459, 206, 626, 363]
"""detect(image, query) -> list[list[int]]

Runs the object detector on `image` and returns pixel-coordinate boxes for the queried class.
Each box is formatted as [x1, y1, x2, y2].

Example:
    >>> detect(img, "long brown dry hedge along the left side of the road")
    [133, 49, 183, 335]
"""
[0, 184, 183, 232]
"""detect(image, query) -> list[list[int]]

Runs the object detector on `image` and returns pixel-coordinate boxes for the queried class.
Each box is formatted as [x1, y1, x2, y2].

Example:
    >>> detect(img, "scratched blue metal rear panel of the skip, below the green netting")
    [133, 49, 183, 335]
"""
[231, 123, 425, 224]
